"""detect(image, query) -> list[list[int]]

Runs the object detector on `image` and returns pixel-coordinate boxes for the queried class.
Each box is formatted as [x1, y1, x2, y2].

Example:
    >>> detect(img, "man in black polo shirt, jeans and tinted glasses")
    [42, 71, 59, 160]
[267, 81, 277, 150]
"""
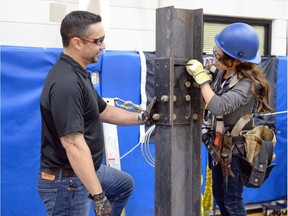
[38, 11, 156, 216]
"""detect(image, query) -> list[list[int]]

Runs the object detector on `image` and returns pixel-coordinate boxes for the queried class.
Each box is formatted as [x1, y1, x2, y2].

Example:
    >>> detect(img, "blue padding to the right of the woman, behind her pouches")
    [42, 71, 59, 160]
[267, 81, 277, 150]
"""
[244, 57, 287, 203]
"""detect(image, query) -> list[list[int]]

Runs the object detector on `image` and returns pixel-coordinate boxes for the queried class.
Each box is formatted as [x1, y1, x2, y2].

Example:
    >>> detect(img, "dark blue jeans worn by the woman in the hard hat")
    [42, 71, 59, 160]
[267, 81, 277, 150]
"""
[212, 154, 246, 216]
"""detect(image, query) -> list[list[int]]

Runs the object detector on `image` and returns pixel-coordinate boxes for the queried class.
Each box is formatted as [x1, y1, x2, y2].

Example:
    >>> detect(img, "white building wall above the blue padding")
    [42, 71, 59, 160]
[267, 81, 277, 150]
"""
[0, 0, 288, 55]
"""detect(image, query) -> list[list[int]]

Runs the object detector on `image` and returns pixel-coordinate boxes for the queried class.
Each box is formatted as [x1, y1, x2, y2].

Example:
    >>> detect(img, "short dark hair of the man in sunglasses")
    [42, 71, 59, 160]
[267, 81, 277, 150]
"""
[60, 11, 102, 47]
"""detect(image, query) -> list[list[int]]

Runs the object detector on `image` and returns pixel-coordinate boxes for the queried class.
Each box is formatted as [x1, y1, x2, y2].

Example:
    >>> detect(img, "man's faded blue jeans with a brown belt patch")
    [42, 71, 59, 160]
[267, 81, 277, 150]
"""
[38, 165, 134, 216]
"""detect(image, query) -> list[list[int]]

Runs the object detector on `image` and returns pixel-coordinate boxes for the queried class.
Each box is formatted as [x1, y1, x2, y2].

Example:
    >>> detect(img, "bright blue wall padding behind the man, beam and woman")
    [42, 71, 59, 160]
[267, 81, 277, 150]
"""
[1, 46, 287, 216]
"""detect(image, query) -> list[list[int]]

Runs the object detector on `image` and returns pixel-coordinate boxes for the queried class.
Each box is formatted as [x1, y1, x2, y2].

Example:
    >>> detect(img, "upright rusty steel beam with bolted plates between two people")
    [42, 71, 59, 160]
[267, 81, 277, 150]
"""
[154, 7, 203, 216]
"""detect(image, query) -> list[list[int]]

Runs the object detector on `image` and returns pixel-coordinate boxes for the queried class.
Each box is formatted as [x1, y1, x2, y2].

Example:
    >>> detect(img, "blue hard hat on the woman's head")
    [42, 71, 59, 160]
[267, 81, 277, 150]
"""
[214, 22, 261, 64]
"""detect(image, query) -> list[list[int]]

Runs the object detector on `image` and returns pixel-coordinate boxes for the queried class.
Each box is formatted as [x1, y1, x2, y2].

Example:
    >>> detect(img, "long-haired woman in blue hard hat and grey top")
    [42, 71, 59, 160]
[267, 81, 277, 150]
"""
[186, 23, 273, 216]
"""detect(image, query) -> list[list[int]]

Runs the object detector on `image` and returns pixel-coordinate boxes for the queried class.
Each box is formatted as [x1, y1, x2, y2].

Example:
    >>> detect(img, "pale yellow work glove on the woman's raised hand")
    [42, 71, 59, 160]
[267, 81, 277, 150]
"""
[186, 59, 212, 85]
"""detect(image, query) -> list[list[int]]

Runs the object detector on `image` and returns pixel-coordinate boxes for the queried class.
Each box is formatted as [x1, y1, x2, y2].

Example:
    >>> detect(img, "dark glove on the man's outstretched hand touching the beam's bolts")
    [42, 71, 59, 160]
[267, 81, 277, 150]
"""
[138, 97, 159, 126]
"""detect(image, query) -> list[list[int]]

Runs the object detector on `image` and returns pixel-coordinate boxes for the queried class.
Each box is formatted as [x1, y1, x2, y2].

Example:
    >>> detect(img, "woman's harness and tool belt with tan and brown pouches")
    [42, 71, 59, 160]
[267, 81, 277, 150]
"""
[202, 67, 276, 187]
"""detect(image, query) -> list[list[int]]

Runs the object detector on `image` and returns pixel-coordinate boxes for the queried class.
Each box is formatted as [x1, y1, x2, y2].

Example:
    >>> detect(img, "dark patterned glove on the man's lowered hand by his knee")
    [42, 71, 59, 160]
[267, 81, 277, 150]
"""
[89, 192, 112, 216]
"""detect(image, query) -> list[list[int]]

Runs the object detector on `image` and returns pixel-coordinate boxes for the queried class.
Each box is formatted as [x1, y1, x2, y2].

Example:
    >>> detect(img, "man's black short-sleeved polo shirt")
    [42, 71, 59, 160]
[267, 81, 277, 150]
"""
[40, 53, 107, 170]
